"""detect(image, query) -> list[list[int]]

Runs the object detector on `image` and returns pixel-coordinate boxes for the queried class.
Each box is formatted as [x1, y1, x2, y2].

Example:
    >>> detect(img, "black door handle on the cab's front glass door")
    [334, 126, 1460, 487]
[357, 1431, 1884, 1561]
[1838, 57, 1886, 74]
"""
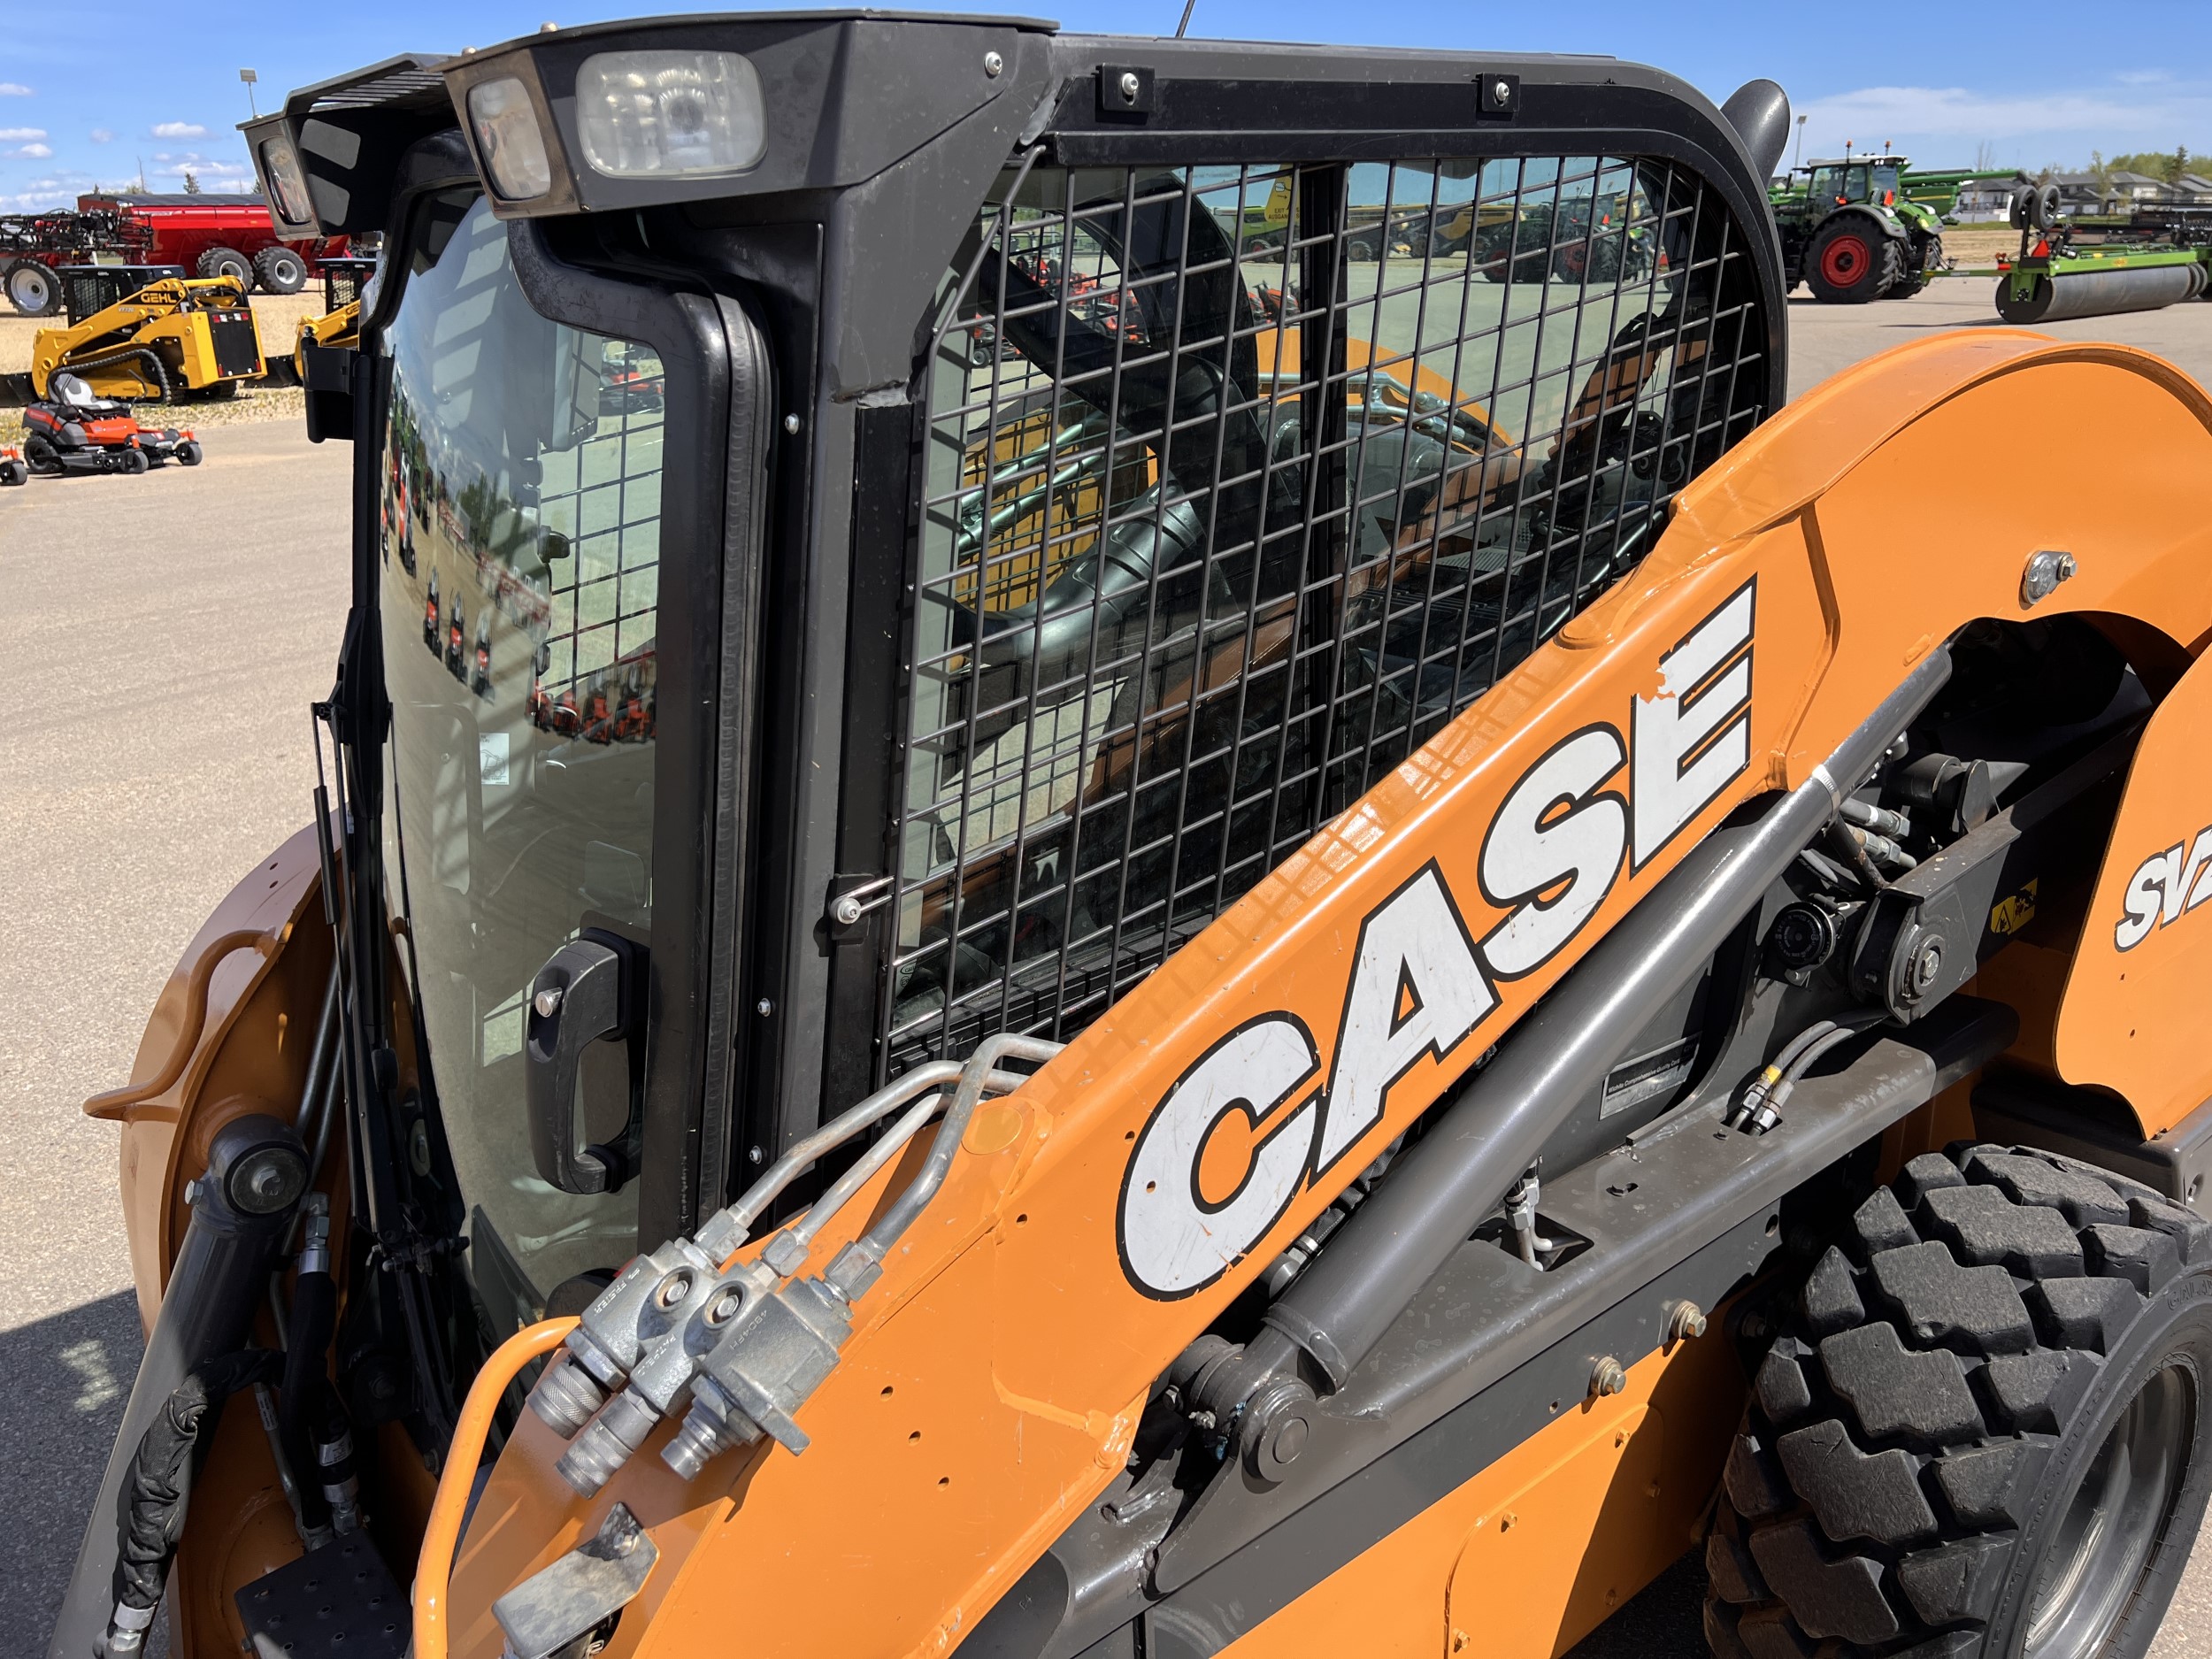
[522, 927, 646, 1193]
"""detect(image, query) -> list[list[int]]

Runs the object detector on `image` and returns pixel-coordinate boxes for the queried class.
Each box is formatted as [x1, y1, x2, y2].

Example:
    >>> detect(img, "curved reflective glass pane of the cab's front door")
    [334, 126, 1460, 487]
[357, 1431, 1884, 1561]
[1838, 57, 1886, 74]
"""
[379, 197, 664, 1318]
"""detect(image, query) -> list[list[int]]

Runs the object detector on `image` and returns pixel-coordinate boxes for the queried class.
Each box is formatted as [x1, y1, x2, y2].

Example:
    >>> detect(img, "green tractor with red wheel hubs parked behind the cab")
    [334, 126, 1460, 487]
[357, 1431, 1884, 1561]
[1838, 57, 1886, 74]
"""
[1768, 155, 1942, 305]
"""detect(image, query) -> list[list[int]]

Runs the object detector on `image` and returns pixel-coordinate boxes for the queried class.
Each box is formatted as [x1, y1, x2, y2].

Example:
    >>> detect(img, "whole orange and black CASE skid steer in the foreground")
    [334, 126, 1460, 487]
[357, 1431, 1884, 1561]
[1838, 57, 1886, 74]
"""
[51, 13, 2212, 1659]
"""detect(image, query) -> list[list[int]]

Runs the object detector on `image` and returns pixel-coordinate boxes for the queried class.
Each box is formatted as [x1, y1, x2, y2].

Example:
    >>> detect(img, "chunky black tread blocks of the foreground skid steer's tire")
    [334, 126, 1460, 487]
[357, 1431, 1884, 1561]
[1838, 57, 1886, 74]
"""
[1706, 1144, 2212, 1659]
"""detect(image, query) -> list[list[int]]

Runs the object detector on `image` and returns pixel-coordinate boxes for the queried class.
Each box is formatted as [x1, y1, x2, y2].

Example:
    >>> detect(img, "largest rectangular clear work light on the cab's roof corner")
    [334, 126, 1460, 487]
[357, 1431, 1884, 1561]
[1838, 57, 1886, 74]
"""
[575, 51, 768, 180]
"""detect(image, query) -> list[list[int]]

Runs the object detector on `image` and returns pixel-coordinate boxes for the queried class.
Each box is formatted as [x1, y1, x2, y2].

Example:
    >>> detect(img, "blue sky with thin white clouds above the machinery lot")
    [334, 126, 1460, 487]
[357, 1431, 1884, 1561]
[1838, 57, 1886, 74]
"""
[0, 0, 2212, 212]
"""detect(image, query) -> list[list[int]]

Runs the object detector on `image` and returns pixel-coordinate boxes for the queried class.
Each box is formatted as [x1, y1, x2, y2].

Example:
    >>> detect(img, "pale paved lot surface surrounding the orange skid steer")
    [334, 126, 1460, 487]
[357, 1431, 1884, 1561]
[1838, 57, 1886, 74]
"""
[0, 298, 2212, 1659]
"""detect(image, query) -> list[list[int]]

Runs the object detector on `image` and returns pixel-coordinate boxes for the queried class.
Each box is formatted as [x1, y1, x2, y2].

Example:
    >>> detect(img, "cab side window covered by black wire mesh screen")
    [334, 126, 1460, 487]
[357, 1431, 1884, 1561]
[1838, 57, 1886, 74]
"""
[883, 157, 1765, 1075]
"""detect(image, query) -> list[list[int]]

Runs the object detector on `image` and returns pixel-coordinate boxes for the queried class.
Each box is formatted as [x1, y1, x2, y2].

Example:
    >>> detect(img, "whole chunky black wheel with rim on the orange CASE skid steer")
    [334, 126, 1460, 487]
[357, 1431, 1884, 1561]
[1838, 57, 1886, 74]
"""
[1706, 1146, 2212, 1659]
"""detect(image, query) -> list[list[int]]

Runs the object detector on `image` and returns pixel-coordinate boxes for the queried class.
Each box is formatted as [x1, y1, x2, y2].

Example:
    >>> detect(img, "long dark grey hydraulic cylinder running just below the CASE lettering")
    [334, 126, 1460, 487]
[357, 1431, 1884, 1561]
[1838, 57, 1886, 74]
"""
[1239, 649, 1951, 1392]
